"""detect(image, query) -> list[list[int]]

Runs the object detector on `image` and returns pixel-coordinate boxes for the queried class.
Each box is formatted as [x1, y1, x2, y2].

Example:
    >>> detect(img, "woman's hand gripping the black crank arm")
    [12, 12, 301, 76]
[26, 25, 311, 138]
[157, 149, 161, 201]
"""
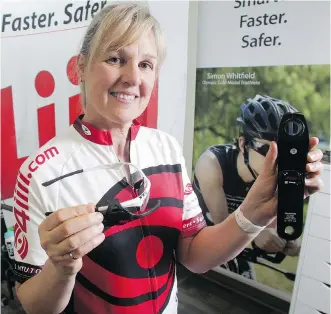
[241, 137, 323, 226]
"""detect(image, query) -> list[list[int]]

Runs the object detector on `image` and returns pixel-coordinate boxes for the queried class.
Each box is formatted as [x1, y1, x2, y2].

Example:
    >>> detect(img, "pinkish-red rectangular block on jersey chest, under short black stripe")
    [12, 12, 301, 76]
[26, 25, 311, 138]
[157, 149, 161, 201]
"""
[148, 172, 184, 200]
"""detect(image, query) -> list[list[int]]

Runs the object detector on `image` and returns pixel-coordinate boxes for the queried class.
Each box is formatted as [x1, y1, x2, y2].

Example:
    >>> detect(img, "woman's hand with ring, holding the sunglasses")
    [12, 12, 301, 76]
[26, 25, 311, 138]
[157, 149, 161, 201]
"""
[38, 204, 105, 277]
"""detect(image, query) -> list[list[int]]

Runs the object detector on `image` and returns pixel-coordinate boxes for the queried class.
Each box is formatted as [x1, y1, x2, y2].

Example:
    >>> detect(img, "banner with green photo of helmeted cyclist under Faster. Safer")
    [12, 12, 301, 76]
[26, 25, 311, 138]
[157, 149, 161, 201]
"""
[192, 1, 330, 301]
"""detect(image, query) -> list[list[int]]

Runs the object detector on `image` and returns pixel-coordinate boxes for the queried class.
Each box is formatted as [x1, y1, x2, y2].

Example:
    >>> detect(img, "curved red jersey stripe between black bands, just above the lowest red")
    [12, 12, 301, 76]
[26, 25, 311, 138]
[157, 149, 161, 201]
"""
[80, 256, 169, 298]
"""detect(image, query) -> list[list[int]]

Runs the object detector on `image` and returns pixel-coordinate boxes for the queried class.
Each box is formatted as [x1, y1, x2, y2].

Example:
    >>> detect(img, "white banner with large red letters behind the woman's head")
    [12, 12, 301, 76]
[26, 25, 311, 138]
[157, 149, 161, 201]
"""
[0, 0, 189, 223]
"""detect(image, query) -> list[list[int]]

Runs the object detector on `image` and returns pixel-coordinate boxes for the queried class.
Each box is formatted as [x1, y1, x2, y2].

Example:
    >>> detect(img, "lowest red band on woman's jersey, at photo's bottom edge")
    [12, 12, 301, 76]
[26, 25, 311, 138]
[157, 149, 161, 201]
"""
[74, 272, 175, 314]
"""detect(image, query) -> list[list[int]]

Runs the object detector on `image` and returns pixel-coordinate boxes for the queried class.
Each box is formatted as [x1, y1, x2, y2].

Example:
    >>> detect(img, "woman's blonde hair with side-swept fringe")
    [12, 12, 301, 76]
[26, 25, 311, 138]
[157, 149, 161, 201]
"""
[80, 2, 165, 107]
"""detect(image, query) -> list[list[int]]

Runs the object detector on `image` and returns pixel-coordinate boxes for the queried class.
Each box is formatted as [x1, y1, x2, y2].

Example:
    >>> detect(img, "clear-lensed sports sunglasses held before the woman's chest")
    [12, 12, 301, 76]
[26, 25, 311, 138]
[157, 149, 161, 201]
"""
[42, 162, 161, 227]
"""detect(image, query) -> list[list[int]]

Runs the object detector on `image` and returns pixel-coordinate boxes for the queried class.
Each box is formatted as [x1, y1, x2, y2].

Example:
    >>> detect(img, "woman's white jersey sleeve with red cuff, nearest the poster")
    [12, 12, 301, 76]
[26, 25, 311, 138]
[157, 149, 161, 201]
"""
[181, 156, 206, 238]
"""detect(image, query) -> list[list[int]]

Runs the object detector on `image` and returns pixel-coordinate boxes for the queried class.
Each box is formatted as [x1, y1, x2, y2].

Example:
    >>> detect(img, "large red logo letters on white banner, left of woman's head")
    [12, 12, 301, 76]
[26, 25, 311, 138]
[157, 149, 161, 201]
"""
[1, 56, 81, 199]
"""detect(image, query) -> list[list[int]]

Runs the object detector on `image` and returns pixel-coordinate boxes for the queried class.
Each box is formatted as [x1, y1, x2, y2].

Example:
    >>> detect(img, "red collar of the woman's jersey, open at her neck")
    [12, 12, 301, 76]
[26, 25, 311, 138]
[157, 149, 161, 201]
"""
[73, 115, 140, 145]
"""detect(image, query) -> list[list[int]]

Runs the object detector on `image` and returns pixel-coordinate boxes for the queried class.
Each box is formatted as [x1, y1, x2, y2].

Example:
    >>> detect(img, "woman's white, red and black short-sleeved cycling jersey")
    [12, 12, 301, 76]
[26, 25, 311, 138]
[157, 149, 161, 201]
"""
[14, 117, 206, 314]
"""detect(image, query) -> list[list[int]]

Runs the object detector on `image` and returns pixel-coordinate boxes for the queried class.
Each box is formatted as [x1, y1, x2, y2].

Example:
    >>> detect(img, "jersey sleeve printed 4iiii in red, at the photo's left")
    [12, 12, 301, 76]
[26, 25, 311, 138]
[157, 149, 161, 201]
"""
[13, 166, 48, 283]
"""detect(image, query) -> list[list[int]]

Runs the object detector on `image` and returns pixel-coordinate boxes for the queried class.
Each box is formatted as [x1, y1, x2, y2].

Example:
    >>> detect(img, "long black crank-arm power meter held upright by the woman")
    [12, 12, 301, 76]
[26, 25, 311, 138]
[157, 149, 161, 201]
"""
[277, 112, 309, 241]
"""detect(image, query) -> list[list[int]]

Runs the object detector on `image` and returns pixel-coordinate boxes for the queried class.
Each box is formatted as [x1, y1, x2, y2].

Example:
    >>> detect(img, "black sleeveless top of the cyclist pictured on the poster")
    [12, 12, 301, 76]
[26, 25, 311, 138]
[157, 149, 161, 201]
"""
[193, 144, 253, 225]
